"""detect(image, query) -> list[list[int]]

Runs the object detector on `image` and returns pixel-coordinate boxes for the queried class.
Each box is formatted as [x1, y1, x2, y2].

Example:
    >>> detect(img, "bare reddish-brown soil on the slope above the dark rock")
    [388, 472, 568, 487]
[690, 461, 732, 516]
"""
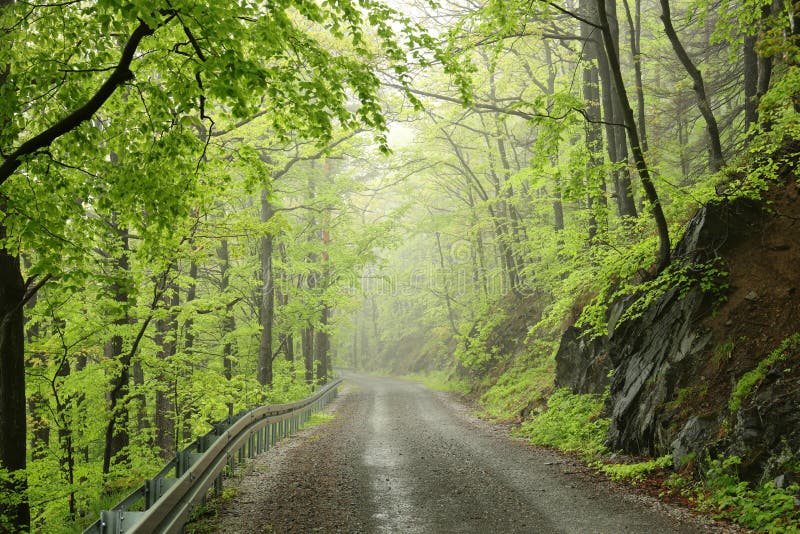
[675, 175, 800, 444]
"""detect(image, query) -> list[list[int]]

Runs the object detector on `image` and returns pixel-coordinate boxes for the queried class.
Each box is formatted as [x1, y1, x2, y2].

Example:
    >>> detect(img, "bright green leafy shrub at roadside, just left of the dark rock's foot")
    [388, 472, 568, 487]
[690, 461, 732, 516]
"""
[519, 388, 609, 457]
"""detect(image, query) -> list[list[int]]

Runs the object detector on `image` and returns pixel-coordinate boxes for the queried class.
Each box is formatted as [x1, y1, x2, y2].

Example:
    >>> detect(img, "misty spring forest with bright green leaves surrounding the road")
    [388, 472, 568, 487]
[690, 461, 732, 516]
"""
[0, 0, 800, 532]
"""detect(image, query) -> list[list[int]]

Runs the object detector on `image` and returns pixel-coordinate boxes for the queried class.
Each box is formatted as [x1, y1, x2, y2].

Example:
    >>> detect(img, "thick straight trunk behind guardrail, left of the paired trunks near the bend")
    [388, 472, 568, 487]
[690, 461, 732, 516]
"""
[258, 188, 275, 385]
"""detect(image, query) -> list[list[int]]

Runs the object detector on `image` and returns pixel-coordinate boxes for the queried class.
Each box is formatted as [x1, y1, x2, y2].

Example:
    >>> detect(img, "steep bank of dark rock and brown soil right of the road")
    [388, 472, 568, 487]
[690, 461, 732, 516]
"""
[556, 156, 800, 486]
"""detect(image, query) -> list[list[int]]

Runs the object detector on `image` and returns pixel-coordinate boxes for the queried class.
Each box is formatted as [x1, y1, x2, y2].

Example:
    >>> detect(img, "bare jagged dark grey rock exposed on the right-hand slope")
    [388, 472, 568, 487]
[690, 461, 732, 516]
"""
[556, 200, 761, 454]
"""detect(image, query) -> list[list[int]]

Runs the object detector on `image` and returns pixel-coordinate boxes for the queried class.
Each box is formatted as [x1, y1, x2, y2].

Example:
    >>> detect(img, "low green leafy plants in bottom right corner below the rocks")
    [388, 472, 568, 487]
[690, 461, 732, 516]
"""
[694, 456, 800, 533]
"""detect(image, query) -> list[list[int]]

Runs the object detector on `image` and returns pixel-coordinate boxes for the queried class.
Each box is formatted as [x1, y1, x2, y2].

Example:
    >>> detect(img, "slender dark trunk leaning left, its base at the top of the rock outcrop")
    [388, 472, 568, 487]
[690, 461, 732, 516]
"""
[597, 0, 671, 272]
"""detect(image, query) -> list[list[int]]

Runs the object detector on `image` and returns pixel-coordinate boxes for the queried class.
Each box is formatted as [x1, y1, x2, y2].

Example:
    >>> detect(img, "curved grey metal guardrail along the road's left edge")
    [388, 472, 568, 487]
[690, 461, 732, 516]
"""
[84, 379, 342, 534]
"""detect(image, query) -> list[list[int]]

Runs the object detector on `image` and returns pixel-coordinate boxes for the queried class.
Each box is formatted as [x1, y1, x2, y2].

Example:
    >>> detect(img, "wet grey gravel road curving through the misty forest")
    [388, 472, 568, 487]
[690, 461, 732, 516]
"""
[209, 375, 719, 534]
